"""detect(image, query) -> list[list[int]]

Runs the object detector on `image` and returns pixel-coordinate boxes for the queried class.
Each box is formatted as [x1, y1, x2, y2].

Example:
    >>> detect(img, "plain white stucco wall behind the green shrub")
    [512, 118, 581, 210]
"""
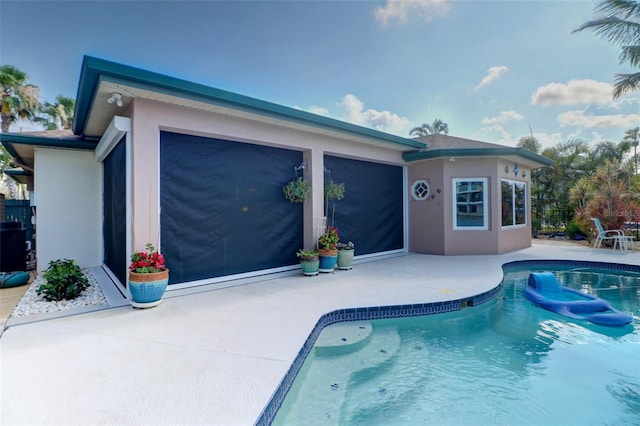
[35, 147, 102, 271]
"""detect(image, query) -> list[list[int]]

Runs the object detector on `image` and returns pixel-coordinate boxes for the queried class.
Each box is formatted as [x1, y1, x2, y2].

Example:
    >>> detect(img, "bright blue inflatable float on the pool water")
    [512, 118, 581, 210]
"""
[523, 272, 633, 326]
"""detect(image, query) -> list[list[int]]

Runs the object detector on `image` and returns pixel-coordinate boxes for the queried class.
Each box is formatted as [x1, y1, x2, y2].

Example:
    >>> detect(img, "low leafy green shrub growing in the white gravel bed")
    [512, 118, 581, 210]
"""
[37, 259, 89, 300]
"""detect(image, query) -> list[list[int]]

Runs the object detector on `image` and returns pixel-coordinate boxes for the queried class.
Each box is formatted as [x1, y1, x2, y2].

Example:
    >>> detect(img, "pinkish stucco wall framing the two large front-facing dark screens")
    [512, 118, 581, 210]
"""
[131, 99, 404, 250]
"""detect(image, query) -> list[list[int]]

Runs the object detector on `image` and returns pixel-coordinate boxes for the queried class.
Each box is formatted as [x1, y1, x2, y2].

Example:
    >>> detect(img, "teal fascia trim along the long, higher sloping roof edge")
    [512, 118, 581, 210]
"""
[73, 56, 426, 149]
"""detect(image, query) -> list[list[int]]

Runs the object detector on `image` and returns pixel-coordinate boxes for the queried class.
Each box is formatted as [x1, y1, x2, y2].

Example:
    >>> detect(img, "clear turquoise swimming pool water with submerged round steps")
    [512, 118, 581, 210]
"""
[273, 268, 640, 425]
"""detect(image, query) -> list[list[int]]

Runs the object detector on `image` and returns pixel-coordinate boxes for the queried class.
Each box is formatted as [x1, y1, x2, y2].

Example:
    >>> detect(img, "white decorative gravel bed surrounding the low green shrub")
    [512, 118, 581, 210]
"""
[9, 268, 109, 318]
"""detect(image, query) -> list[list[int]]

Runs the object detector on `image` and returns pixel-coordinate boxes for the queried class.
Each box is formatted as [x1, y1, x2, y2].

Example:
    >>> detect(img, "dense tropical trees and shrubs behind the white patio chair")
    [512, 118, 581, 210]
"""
[521, 129, 640, 235]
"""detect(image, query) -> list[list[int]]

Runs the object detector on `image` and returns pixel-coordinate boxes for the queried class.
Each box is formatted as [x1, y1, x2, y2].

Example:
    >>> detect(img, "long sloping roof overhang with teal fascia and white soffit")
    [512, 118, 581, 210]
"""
[73, 56, 426, 152]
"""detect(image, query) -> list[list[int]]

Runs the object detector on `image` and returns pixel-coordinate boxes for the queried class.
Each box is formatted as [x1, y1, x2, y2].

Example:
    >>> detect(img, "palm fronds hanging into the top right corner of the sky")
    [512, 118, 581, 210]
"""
[573, 0, 640, 99]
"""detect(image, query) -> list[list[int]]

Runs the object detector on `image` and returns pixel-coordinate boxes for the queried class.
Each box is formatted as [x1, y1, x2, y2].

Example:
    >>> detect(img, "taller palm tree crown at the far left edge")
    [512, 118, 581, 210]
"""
[0, 65, 40, 133]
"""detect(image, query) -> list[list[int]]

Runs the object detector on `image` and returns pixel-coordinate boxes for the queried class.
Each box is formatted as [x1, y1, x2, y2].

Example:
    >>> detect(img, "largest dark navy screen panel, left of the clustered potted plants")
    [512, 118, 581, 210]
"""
[160, 132, 303, 284]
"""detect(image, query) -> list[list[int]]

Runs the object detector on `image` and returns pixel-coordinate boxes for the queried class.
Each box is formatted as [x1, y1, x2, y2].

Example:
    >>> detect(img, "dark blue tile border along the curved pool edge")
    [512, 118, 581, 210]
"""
[255, 259, 640, 426]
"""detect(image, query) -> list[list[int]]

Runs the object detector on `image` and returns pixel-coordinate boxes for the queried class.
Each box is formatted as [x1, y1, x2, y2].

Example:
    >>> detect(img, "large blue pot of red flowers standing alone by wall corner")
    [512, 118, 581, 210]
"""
[129, 243, 169, 308]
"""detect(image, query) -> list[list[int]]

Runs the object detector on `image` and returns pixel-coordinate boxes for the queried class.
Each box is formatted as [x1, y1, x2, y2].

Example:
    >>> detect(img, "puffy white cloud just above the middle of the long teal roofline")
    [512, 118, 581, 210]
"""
[338, 94, 412, 136]
